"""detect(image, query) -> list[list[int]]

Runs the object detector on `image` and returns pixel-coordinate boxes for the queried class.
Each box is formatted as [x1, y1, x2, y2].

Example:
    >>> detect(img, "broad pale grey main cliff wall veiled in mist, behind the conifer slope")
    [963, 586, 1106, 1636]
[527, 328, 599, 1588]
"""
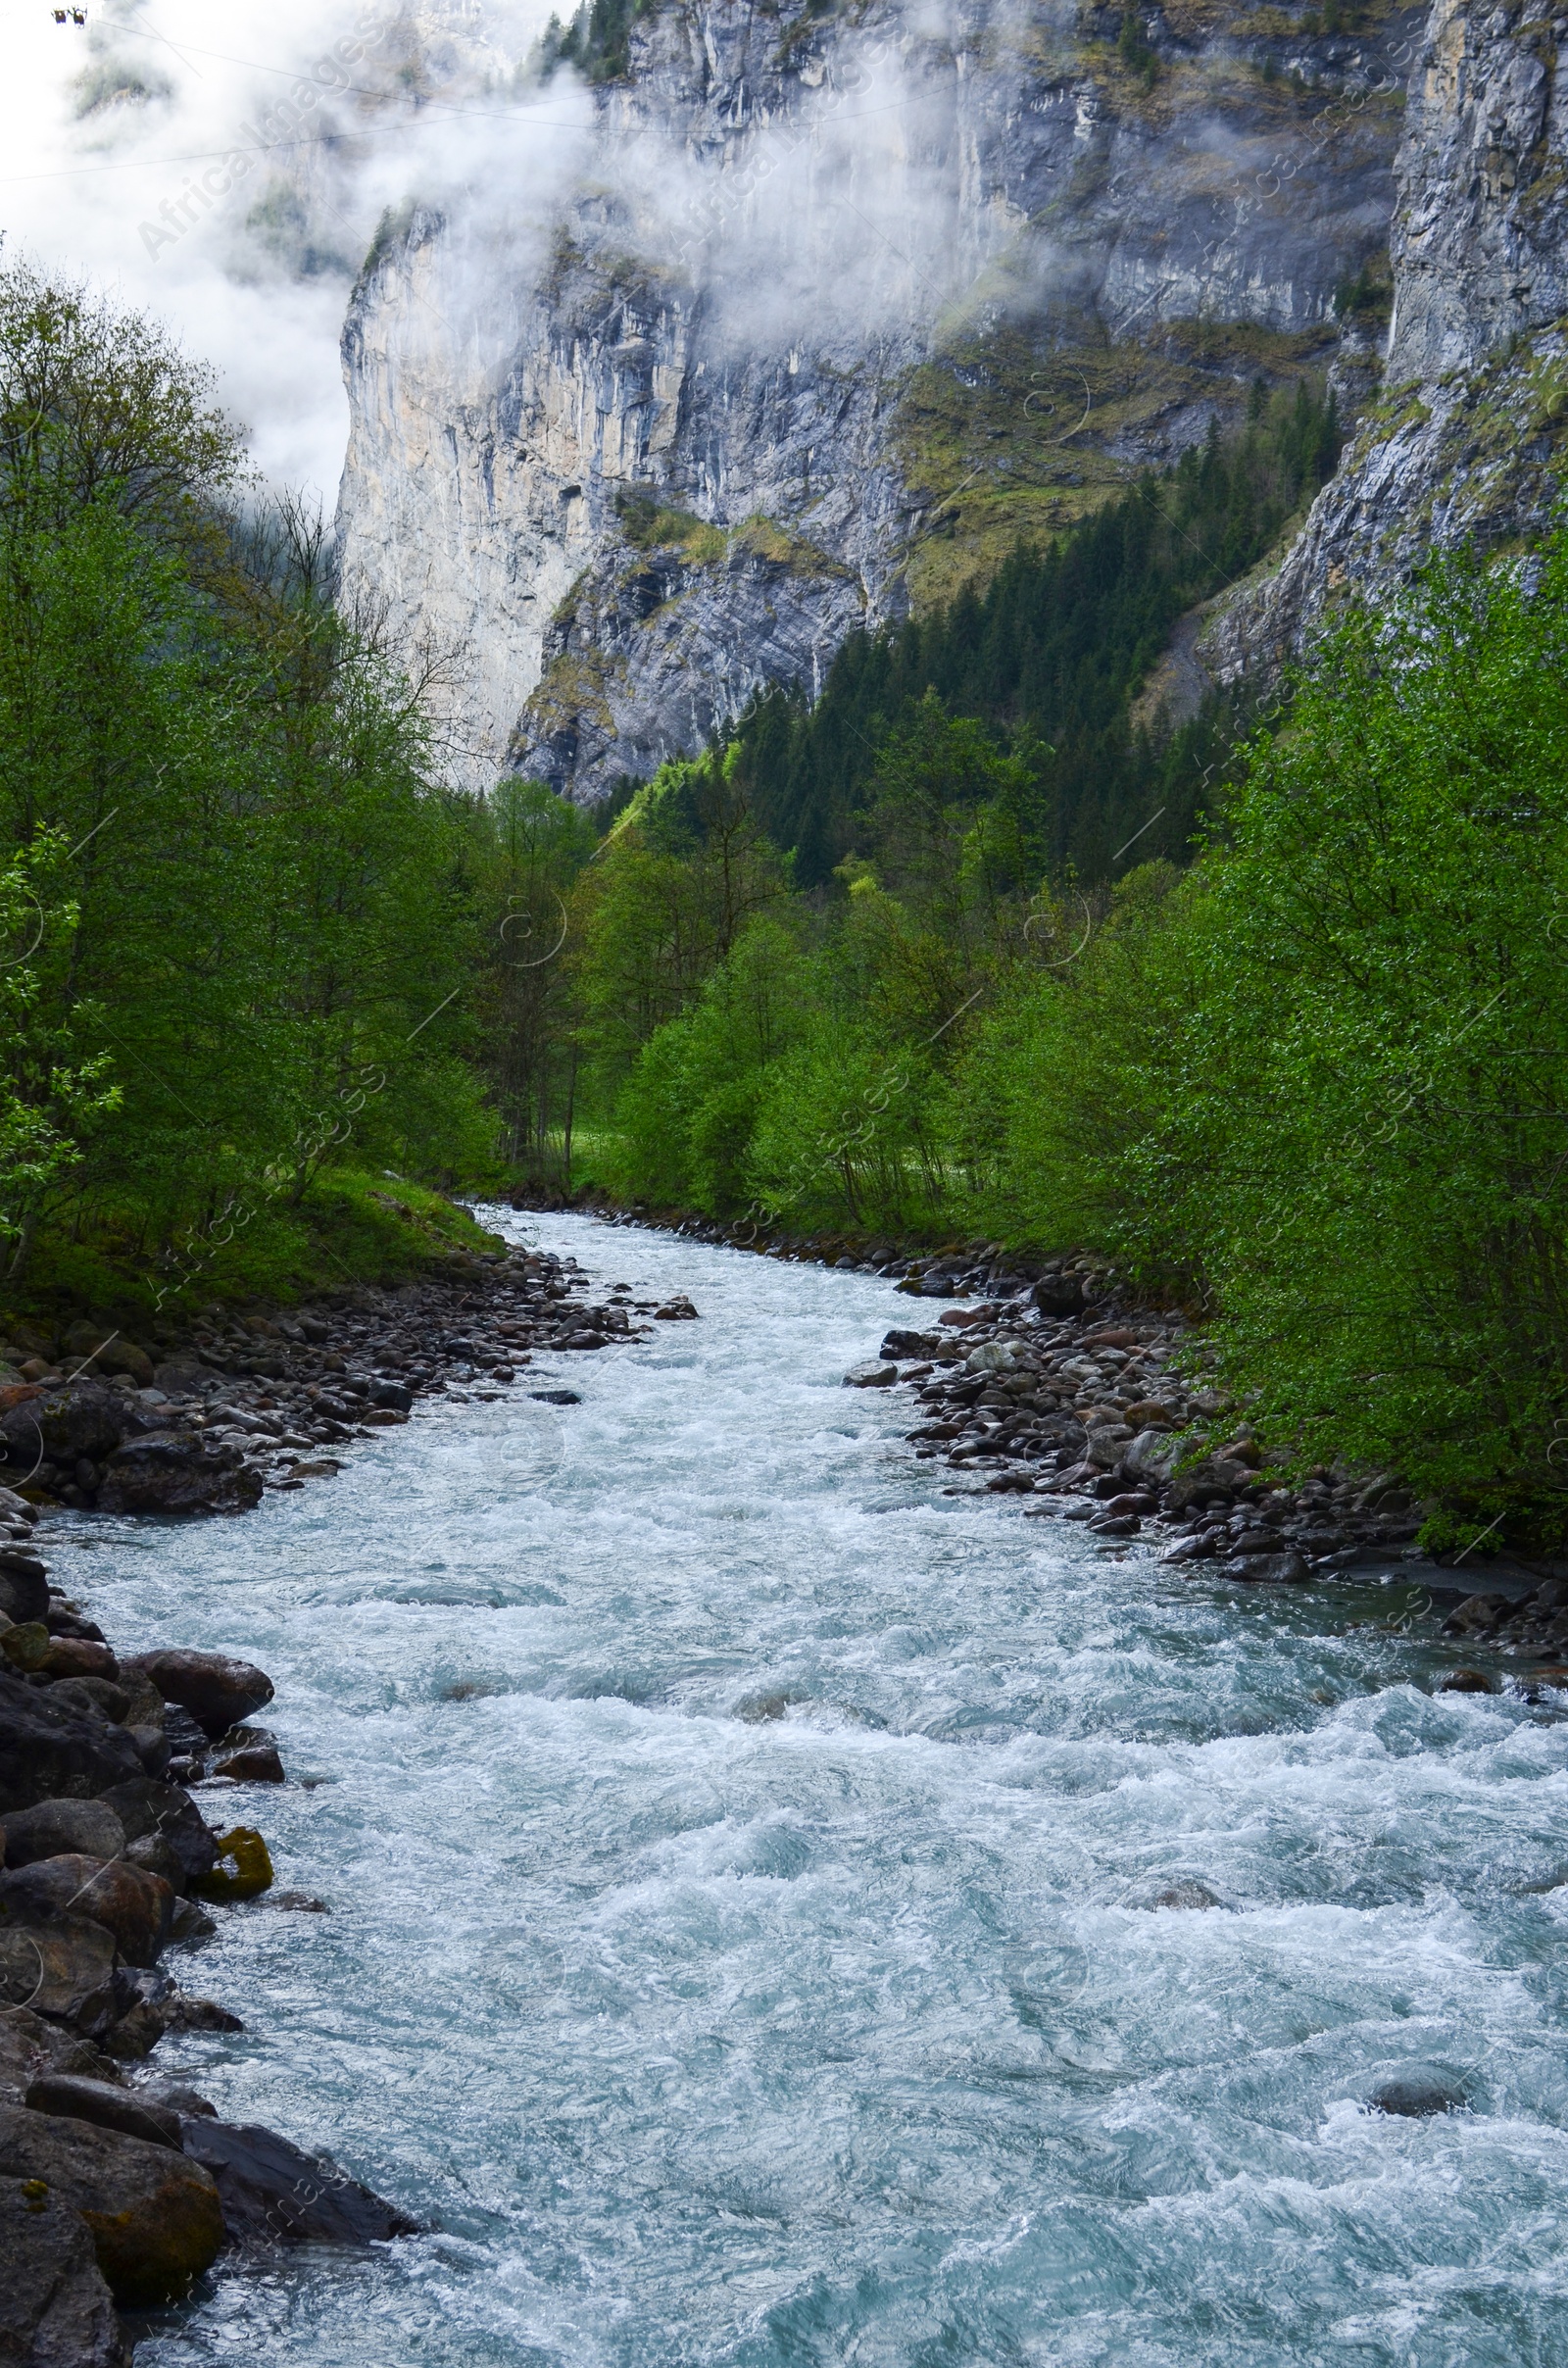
[339, 0, 1436, 801]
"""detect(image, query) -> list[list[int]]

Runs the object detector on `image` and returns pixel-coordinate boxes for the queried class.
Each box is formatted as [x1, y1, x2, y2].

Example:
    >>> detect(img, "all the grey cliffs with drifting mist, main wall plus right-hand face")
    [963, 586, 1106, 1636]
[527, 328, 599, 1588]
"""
[328, 0, 1563, 801]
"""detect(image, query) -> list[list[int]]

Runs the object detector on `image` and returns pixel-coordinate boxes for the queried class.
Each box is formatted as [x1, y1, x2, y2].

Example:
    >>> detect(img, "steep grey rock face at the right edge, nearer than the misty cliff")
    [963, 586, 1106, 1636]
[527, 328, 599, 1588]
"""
[1203, 0, 1568, 679]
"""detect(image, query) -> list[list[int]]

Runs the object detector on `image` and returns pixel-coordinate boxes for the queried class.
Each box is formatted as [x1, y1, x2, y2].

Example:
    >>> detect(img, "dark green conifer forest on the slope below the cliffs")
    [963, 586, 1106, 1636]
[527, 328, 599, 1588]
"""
[739, 383, 1341, 886]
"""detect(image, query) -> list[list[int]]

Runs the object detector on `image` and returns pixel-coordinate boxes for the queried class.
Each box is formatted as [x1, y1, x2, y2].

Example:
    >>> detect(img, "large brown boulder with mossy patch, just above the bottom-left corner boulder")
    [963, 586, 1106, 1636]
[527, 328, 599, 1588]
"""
[0, 2105, 222, 2309]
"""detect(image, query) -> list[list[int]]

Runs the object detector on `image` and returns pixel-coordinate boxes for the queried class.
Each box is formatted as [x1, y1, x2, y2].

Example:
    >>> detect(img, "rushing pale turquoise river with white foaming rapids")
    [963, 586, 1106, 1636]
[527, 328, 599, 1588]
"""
[57, 1214, 1568, 2368]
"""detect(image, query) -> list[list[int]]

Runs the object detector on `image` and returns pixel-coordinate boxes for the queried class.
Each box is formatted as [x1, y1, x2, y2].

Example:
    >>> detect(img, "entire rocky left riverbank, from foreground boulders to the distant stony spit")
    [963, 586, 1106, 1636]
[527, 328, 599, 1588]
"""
[0, 1251, 694, 2368]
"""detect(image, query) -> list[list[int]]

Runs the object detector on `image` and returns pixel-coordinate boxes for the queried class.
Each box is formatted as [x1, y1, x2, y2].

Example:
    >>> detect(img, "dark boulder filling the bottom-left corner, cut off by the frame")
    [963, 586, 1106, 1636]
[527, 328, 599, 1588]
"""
[0, 2179, 130, 2368]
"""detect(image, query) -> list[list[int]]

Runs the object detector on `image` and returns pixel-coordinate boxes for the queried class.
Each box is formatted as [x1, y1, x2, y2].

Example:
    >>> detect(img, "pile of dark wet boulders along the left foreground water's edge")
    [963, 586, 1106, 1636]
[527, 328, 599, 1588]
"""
[0, 1601, 415, 2368]
